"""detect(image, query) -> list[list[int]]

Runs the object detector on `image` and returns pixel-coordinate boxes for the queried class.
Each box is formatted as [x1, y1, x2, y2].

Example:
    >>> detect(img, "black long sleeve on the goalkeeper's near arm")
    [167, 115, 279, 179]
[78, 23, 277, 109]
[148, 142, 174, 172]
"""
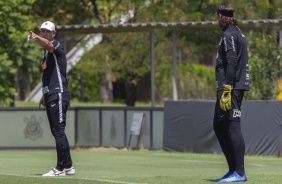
[223, 32, 237, 85]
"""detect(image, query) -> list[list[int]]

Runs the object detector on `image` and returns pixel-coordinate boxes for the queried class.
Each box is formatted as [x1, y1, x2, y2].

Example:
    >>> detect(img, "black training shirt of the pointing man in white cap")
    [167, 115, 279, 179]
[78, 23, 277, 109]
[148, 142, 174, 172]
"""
[42, 40, 68, 95]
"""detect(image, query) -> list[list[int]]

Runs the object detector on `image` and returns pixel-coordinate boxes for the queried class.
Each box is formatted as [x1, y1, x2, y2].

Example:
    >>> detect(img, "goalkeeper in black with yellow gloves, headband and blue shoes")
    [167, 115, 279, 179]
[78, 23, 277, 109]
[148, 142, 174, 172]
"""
[213, 3, 250, 182]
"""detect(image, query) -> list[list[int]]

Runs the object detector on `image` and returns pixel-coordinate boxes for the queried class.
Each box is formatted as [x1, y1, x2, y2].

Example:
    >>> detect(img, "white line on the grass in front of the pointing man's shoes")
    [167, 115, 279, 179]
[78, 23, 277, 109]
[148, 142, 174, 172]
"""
[0, 173, 146, 184]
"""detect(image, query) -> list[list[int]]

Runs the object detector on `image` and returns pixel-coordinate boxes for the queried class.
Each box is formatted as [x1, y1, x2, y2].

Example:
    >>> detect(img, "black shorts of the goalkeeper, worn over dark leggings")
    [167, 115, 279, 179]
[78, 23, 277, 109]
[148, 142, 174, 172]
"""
[214, 90, 245, 122]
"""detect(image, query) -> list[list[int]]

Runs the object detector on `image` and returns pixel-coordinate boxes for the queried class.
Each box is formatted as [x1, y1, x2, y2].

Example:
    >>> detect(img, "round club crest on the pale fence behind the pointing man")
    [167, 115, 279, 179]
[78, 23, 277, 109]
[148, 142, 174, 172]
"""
[24, 115, 43, 141]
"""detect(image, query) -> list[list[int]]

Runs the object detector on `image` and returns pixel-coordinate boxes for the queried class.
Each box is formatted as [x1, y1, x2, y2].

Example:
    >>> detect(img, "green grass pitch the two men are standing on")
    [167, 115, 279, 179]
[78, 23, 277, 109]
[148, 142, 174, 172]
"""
[0, 149, 282, 184]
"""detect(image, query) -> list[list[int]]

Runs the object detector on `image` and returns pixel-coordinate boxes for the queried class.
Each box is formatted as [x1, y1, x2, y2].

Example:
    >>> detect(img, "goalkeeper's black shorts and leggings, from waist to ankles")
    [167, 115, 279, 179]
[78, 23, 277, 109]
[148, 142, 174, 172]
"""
[213, 90, 245, 175]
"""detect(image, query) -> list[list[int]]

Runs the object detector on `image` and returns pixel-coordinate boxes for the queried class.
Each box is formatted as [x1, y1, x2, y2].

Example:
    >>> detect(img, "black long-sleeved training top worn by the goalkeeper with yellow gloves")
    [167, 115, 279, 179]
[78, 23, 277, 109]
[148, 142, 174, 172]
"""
[216, 25, 250, 90]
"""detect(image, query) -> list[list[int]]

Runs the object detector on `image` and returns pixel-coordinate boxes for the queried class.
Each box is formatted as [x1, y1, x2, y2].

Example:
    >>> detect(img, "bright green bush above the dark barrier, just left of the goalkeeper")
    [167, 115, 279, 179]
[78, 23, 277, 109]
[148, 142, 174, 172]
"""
[156, 64, 216, 102]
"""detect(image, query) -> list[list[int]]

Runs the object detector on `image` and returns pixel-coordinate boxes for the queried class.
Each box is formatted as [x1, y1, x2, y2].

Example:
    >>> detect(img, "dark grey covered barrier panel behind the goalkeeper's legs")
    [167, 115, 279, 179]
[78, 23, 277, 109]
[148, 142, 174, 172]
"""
[163, 100, 282, 155]
